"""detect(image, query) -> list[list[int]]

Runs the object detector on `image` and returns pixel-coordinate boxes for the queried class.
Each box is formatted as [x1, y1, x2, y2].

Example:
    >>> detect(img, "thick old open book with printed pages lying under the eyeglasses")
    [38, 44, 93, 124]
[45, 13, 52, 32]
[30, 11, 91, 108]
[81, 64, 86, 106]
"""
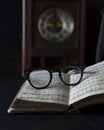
[8, 61, 104, 113]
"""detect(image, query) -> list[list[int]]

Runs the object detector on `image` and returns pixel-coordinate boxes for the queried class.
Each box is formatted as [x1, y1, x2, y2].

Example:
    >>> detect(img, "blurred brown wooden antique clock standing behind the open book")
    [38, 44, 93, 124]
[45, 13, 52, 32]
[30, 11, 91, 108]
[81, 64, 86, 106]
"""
[22, 0, 86, 71]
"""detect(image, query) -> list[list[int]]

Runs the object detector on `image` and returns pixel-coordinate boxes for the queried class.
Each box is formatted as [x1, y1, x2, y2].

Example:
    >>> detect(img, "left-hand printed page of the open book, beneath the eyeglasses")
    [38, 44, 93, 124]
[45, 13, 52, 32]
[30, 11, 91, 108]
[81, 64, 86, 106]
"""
[16, 72, 69, 105]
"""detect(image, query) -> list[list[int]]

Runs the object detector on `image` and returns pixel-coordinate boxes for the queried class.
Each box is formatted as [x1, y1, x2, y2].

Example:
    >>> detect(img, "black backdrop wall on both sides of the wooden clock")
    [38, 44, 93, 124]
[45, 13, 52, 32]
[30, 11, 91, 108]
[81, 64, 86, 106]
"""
[0, 0, 104, 75]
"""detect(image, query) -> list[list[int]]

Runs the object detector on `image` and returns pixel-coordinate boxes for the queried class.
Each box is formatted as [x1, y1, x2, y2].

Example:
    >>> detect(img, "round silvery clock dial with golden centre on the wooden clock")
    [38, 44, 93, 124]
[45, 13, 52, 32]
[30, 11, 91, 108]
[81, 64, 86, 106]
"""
[38, 7, 74, 43]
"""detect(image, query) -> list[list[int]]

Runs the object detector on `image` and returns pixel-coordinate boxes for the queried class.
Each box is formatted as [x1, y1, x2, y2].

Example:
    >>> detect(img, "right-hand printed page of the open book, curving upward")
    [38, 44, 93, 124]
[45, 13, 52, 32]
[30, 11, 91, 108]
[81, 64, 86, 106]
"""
[69, 61, 104, 104]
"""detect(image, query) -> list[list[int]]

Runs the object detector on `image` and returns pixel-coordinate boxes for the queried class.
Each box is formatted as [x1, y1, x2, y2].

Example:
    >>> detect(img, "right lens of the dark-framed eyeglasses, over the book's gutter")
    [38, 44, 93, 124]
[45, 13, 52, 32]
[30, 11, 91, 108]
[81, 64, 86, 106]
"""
[61, 66, 81, 85]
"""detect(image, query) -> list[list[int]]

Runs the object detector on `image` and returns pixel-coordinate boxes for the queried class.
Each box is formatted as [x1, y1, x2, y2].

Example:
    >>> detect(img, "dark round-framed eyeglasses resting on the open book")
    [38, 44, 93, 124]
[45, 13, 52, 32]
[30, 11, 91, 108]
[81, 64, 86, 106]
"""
[22, 66, 85, 89]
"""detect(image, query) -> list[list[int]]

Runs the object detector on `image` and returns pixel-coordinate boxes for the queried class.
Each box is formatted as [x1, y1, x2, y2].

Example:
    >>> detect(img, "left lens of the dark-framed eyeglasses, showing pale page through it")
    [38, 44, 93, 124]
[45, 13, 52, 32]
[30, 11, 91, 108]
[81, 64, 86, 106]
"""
[29, 70, 50, 88]
